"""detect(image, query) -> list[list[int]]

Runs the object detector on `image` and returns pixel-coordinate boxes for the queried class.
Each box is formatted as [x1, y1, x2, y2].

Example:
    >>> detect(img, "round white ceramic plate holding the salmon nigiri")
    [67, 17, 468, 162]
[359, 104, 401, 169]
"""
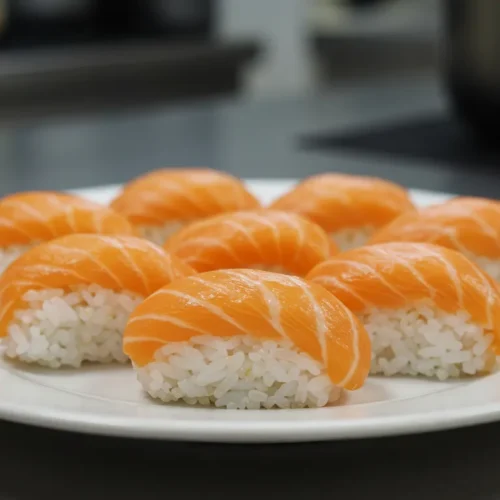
[0, 180, 500, 442]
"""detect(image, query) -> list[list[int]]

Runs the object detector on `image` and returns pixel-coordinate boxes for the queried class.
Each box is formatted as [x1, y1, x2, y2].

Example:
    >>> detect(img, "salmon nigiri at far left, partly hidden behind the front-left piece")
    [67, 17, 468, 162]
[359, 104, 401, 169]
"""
[0, 191, 135, 274]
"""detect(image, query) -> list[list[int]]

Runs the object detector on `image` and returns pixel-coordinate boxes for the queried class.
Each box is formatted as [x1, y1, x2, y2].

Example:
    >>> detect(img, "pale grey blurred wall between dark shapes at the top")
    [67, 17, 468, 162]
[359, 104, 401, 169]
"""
[217, 0, 438, 96]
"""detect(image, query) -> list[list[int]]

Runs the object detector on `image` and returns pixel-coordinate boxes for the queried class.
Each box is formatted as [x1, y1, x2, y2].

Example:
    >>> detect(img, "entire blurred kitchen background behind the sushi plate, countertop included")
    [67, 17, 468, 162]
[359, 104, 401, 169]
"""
[4, 0, 500, 198]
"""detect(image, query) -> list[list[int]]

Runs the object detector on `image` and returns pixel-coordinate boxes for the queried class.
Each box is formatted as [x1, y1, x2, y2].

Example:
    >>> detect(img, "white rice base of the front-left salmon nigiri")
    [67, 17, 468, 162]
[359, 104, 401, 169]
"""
[4, 285, 143, 368]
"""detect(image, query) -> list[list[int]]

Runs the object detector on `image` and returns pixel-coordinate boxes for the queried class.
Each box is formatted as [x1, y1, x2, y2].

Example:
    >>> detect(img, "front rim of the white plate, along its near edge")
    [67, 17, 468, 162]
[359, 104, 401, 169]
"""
[0, 384, 500, 444]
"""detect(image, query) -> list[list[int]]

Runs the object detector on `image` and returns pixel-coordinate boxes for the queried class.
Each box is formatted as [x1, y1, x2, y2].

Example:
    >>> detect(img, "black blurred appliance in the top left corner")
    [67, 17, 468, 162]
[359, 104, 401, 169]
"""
[0, 0, 215, 49]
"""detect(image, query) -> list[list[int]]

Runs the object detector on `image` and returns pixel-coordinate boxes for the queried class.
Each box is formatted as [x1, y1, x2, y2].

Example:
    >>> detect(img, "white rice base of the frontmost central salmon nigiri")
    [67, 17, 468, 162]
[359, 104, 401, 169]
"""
[137, 335, 341, 409]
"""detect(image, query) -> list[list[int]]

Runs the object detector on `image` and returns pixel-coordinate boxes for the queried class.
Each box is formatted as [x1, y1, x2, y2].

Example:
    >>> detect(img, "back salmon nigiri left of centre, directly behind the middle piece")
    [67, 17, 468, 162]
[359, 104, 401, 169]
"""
[111, 168, 260, 244]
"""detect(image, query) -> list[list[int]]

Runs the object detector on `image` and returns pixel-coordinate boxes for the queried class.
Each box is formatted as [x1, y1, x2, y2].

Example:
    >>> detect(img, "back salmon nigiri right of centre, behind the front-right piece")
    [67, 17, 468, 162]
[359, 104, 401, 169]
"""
[270, 173, 415, 251]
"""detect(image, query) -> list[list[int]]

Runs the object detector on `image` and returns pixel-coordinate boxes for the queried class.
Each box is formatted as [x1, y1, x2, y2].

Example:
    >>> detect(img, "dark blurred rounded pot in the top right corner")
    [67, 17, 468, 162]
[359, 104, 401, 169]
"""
[443, 0, 500, 142]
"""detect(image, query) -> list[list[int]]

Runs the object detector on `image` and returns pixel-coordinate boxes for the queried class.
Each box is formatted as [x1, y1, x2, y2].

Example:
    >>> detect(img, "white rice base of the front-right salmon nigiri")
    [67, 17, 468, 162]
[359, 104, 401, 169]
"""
[360, 303, 498, 380]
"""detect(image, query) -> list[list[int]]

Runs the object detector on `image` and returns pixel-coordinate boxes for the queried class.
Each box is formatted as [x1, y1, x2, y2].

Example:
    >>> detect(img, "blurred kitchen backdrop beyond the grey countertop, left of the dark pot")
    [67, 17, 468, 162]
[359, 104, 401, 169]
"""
[0, 0, 439, 118]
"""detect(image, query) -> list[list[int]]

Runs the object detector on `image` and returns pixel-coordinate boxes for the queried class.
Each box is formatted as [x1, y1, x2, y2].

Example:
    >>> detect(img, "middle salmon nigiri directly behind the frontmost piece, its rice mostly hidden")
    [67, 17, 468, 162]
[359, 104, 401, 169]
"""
[165, 209, 337, 276]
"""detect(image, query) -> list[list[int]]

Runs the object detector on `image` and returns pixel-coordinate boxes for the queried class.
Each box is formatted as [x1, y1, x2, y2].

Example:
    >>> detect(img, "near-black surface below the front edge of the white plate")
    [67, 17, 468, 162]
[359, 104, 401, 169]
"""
[0, 418, 500, 500]
